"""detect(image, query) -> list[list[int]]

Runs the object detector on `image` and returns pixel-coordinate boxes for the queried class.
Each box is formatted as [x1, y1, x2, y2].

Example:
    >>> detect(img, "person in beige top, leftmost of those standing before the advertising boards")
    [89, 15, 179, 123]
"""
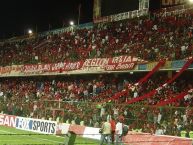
[100, 119, 111, 145]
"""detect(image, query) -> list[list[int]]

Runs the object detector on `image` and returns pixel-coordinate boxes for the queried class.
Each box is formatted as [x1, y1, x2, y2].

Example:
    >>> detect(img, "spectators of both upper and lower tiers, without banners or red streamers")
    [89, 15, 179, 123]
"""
[0, 5, 193, 137]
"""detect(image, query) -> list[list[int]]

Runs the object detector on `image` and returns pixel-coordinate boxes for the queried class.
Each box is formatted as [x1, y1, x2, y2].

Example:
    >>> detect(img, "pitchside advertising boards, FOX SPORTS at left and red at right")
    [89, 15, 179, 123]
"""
[0, 114, 192, 145]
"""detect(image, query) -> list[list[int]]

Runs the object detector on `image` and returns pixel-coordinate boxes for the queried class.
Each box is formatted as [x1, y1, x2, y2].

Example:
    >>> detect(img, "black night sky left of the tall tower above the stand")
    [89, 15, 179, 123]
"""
[0, 0, 159, 39]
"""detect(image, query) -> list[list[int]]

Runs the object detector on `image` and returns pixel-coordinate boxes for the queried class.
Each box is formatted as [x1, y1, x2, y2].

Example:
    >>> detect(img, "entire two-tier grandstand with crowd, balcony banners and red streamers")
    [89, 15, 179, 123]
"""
[0, 1, 193, 145]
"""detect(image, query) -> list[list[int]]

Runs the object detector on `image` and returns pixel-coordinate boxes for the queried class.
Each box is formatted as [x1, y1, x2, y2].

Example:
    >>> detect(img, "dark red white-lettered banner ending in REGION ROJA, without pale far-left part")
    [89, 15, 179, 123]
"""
[23, 56, 146, 74]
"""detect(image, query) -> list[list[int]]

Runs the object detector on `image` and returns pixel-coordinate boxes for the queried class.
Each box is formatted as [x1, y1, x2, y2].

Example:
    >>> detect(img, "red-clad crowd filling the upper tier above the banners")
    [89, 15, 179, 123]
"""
[0, 11, 193, 66]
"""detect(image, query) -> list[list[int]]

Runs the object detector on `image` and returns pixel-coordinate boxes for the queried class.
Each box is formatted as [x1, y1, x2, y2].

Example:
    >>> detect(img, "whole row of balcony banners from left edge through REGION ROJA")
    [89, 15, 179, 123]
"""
[0, 56, 147, 76]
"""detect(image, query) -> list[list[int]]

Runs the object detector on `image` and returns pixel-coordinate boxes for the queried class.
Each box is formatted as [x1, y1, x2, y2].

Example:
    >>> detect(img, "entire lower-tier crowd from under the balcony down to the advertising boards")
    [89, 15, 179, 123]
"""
[0, 72, 193, 135]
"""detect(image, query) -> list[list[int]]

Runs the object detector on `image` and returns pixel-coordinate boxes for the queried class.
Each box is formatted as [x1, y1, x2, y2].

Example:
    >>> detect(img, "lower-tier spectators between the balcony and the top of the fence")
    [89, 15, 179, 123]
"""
[0, 72, 193, 106]
